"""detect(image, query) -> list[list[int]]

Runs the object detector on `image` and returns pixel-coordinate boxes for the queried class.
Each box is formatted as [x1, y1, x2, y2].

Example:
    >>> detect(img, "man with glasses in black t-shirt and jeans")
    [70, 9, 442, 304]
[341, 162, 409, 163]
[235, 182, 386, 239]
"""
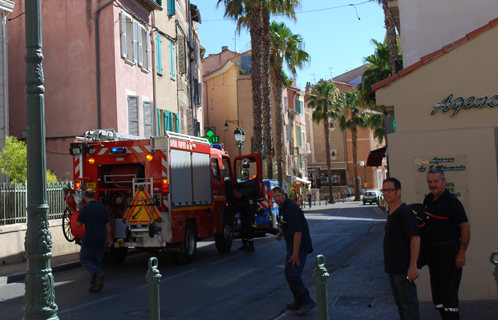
[382, 178, 420, 320]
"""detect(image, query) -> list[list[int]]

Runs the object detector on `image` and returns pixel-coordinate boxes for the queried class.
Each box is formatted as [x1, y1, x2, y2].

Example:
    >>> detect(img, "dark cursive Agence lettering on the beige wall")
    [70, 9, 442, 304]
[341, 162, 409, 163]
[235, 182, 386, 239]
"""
[431, 93, 498, 117]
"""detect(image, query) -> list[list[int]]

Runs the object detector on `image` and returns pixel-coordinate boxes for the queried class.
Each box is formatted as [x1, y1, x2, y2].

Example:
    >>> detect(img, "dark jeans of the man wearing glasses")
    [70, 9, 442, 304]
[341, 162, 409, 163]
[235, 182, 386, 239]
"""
[389, 273, 420, 320]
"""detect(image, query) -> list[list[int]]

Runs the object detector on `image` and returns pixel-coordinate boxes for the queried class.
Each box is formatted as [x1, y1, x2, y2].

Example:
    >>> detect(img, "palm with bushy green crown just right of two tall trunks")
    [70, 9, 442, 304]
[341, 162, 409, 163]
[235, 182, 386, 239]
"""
[270, 21, 310, 185]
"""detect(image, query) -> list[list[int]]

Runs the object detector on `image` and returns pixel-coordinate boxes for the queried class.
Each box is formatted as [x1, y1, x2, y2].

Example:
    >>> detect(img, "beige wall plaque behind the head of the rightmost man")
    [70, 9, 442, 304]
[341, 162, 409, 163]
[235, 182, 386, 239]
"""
[412, 156, 468, 207]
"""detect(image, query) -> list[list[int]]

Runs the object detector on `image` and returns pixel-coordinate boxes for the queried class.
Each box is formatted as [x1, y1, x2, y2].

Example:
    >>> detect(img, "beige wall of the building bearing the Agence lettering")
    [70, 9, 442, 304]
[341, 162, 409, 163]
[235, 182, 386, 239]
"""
[376, 27, 498, 301]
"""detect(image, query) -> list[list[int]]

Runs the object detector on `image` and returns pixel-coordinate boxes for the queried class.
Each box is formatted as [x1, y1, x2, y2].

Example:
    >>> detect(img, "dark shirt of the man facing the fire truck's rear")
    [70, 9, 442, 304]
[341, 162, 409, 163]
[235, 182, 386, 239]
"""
[77, 201, 109, 248]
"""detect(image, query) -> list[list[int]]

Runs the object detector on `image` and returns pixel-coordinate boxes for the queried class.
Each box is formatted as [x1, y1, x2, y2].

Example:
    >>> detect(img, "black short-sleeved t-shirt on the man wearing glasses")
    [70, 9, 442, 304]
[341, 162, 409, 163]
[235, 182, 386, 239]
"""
[384, 203, 419, 274]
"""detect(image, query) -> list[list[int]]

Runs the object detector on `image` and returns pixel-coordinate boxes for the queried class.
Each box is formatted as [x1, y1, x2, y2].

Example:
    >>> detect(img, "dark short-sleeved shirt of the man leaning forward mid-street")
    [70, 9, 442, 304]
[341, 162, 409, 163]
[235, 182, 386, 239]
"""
[279, 199, 311, 253]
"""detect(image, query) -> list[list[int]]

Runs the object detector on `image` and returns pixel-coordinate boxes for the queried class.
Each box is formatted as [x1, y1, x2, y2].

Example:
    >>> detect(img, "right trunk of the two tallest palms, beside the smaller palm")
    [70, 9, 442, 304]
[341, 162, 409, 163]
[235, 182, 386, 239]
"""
[262, 10, 273, 179]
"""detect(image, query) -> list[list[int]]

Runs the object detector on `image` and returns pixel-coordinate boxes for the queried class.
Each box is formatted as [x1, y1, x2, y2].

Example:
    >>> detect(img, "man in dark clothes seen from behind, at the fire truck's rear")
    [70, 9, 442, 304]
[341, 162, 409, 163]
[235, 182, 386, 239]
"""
[77, 189, 112, 292]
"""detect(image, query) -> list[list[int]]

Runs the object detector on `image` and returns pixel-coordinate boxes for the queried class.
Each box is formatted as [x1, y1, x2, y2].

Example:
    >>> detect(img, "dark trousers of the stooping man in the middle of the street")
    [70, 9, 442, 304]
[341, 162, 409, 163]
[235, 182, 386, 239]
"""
[285, 252, 313, 307]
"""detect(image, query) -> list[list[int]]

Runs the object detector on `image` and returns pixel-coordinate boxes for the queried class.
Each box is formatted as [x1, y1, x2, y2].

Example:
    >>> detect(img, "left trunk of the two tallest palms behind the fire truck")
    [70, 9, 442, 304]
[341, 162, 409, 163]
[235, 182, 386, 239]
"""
[250, 5, 263, 154]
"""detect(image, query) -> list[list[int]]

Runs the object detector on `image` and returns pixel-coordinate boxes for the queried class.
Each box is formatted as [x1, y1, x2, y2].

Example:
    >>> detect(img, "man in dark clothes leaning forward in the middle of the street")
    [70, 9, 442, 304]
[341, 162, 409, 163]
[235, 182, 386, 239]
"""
[271, 187, 316, 316]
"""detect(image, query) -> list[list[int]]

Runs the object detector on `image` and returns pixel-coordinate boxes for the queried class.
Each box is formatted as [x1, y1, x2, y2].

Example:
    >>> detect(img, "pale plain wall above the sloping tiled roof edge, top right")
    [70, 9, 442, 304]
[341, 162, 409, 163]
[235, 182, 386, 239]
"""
[391, 0, 498, 68]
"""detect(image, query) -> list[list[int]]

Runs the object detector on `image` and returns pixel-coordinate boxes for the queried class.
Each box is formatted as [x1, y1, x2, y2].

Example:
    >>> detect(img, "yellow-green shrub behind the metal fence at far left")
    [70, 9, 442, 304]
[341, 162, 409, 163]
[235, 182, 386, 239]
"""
[0, 136, 58, 183]
